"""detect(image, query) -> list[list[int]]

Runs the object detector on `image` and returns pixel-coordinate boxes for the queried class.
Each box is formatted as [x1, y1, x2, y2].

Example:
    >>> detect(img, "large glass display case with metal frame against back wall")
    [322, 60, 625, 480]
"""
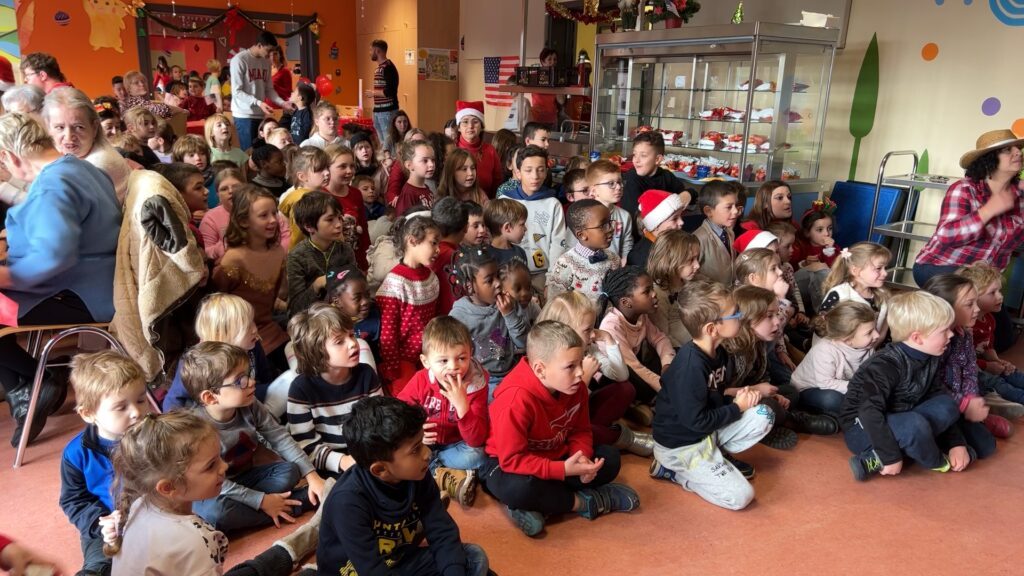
[591, 23, 839, 184]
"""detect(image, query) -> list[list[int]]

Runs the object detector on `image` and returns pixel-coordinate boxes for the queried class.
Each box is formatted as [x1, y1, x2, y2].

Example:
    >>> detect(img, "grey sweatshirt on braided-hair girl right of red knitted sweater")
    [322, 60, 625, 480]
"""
[451, 296, 529, 376]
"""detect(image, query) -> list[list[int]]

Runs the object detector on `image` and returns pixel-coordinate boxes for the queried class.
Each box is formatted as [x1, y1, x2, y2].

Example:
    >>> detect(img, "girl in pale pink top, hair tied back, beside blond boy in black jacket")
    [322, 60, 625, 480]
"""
[791, 300, 879, 418]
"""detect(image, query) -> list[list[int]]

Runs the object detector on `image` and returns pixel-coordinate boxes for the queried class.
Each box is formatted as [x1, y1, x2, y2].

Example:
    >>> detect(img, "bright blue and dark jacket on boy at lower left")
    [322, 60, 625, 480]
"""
[60, 424, 115, 538]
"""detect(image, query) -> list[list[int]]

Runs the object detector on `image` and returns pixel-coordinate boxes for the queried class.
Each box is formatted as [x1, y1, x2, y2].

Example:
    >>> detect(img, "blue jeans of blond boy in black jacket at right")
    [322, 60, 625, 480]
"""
[843, 395, 959, 468]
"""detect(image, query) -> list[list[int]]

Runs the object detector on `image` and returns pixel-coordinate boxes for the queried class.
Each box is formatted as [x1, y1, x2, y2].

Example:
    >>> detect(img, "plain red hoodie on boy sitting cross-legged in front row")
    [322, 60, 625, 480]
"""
[485, 358, 594, 480]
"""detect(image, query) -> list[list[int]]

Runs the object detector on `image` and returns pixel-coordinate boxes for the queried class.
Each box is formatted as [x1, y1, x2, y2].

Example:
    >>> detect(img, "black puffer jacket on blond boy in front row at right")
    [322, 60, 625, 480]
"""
[840, 343, 966, 464]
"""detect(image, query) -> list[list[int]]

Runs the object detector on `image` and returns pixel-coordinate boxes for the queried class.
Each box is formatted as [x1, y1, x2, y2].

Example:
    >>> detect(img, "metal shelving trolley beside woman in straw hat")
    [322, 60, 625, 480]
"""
[871, 150, 958, 288]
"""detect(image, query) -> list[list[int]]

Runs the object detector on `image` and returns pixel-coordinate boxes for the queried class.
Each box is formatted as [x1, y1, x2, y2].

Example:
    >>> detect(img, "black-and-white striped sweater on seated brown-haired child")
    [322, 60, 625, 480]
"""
[288, 364, 383, 474]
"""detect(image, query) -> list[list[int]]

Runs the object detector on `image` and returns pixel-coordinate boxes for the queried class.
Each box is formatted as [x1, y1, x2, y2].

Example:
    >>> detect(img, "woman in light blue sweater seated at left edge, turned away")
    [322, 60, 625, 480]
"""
[0, 113, 121, 446]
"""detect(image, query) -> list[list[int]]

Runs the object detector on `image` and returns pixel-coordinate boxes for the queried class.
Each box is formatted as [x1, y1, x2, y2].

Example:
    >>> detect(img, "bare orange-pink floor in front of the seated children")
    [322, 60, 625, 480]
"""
[0, 345, 1024, 576]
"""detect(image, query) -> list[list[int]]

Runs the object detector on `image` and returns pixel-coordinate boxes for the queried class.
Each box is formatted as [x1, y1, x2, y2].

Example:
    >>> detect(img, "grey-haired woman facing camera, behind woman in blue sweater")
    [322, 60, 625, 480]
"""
[42, 88, 131, 203]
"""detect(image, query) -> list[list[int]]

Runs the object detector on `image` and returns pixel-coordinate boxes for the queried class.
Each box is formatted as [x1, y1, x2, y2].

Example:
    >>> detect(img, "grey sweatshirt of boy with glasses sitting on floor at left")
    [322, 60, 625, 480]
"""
[196, 400, 313, 510]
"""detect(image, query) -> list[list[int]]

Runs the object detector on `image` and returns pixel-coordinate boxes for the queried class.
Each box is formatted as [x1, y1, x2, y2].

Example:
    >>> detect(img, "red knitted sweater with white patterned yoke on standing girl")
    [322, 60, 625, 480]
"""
[377, 262, 440, 387]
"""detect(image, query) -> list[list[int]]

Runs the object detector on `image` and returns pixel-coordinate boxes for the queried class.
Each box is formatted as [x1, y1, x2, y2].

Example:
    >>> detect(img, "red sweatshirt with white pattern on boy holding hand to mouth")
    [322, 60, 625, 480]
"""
[398, 360, 488, 448]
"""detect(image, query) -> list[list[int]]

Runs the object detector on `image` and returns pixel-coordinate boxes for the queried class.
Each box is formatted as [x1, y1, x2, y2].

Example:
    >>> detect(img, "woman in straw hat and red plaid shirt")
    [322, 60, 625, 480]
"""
[913, 130, 1024, 286]
